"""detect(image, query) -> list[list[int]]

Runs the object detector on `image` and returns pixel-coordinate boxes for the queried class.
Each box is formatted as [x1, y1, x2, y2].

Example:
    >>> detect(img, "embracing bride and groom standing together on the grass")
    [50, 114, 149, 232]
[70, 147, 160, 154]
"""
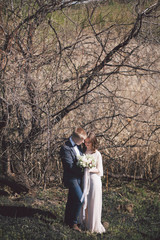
[60, 127, 105, 233]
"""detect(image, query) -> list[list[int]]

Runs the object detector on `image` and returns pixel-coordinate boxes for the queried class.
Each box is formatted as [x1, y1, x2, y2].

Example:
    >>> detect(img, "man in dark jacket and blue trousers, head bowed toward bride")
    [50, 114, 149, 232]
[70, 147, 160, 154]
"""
[60, 127, 87, 231]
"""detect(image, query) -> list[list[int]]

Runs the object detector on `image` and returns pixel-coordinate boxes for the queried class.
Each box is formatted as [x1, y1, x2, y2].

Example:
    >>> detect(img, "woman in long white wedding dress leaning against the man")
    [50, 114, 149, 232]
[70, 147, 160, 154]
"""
[82, 133, 106, 233]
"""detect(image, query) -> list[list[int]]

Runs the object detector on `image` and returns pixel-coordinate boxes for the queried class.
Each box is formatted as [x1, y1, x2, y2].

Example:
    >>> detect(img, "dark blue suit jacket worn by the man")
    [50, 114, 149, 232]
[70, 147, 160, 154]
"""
[60, 140, 83, 187]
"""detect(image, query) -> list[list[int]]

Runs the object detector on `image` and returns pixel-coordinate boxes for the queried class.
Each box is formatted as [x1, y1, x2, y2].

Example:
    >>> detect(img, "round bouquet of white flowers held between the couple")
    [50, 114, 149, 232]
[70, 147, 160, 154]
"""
[77, 154, 96, 168]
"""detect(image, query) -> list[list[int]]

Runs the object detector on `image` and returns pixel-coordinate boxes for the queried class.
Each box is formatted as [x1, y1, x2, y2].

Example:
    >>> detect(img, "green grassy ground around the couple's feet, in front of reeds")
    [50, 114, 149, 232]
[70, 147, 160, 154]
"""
[0, 182, 160, 240]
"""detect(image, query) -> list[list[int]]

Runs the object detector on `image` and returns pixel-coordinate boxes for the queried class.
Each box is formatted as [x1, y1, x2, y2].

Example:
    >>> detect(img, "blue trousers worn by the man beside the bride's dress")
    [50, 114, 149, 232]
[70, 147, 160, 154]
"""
[64, 178, 83, 226]
